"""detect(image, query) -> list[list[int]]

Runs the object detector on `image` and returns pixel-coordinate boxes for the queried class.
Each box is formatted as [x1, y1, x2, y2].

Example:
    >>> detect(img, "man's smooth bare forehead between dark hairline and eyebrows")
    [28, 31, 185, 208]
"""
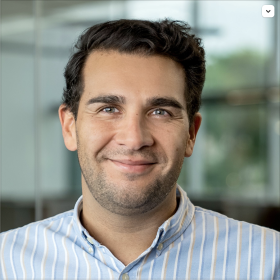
[82, 51, 185, 102]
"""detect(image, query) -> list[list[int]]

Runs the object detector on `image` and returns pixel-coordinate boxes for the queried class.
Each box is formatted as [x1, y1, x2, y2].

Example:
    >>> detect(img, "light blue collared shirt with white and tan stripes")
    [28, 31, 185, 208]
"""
[0, 186, 280, 280]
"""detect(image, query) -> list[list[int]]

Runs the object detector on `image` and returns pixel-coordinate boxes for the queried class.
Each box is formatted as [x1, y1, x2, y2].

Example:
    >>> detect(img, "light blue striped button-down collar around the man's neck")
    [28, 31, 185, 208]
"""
[74, 184, 195, 247]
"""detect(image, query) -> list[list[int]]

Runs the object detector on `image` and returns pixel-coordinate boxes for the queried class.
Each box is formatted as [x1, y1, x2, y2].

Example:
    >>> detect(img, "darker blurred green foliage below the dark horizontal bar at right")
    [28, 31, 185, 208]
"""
[203, 106, 267, 194]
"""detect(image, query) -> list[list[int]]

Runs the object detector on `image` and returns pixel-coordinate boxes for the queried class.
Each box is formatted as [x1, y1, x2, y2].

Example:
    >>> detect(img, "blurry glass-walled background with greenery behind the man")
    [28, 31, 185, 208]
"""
[0, 0, 280, 231]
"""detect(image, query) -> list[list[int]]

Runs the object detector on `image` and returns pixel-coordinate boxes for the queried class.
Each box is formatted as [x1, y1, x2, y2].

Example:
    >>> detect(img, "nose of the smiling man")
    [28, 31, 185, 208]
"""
[115, 113, 154, 151]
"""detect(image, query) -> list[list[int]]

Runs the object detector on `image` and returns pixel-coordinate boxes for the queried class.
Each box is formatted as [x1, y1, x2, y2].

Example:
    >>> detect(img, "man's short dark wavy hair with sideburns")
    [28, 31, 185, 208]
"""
[62, 19, 205, 124]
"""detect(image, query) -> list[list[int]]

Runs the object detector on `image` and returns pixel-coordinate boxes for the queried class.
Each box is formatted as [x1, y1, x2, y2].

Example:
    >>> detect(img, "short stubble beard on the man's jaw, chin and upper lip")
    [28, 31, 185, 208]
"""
[77, 137, 184, 216]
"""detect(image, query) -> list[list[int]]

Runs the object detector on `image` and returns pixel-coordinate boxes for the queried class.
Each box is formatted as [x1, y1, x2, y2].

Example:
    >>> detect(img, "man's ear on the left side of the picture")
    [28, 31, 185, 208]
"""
[58, 104, 77, 151]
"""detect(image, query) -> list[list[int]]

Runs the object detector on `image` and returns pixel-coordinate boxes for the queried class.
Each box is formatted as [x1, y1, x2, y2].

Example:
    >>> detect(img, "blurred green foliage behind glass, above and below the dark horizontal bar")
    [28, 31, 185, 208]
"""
[179, 50, 267, 197]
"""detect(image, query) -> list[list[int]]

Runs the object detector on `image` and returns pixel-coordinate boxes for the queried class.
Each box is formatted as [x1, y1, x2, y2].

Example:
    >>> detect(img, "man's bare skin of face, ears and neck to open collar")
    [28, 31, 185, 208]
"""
[59, 51, 201, 265]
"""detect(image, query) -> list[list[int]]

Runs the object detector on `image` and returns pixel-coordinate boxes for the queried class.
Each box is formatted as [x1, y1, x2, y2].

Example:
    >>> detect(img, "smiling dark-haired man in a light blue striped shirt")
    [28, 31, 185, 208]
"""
[1, 20, 280, 280]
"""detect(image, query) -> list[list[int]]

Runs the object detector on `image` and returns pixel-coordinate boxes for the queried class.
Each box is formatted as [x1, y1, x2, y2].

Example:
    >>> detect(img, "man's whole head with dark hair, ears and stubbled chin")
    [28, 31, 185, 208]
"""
[59, 20, 205, 215]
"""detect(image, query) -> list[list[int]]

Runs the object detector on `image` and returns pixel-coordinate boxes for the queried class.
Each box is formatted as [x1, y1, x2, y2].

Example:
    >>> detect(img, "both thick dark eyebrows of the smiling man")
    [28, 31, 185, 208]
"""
[86, 95, 185, 110]
